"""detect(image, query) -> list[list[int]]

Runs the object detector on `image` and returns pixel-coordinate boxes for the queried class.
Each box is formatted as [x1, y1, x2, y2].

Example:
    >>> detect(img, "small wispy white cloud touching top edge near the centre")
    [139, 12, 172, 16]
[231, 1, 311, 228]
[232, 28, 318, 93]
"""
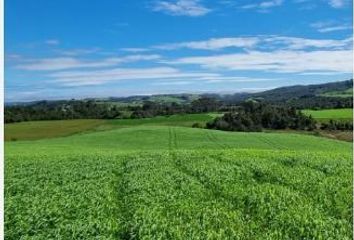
[153, 0, 211, 17]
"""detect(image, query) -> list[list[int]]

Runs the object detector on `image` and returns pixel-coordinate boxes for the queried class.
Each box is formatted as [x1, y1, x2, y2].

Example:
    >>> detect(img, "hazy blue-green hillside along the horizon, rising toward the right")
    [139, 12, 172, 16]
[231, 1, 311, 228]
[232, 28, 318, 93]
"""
[6, 79, 353, 106]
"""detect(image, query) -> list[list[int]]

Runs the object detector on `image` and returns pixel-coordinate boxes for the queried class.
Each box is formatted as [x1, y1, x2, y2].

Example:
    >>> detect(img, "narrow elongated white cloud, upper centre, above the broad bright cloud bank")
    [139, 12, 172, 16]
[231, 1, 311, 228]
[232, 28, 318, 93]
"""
[155, 37, 259, 50]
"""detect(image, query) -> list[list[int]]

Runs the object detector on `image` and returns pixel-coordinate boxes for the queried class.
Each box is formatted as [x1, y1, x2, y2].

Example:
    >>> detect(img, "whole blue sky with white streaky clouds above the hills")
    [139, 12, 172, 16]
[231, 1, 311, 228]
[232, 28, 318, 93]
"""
[5, 0, 353, 101]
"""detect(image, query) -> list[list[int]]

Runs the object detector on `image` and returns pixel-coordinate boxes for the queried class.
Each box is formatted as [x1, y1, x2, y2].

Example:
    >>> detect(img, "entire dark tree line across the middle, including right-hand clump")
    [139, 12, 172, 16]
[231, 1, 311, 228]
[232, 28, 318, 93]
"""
[5, 96, 353, 131]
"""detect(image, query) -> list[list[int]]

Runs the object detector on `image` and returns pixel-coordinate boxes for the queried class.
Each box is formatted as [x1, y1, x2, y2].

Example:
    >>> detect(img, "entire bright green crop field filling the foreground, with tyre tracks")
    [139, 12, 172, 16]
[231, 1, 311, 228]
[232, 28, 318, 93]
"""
[5, 125, 353, 240]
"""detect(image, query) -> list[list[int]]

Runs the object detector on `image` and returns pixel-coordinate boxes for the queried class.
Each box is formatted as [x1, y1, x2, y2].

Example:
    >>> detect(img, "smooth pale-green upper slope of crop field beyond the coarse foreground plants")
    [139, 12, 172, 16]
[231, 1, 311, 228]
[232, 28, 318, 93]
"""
[6, 126, 350, 154]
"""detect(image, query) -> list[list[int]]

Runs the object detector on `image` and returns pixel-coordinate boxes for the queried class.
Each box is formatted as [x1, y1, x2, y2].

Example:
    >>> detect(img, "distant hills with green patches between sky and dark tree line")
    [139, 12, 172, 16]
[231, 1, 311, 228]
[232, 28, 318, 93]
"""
[6, 79, 353, 108]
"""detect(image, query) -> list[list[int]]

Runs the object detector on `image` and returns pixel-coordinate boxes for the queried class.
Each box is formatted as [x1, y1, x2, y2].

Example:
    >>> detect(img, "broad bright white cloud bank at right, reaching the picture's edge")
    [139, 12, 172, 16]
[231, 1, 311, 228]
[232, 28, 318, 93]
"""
[169, 50, 353, 73]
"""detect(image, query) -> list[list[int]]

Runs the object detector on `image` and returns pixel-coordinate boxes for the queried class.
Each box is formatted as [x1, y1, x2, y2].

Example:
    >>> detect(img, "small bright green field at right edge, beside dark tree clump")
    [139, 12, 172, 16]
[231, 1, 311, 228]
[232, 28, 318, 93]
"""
[302, 108, 353, 121]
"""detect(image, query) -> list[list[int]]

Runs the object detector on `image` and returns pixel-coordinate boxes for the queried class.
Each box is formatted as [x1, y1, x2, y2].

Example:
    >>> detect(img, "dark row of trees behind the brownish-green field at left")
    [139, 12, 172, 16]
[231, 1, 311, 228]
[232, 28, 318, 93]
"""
[5, 98, 221, 123]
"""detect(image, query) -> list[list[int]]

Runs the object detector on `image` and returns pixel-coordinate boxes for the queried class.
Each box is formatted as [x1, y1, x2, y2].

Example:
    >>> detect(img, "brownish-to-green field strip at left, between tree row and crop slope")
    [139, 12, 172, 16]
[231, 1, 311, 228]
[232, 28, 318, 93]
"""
[5, 113, 220, 141]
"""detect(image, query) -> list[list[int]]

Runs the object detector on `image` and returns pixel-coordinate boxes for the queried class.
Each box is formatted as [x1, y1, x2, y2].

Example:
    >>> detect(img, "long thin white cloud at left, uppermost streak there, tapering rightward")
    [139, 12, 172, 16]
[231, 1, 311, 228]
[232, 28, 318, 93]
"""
[16, 55, 160, 71]
